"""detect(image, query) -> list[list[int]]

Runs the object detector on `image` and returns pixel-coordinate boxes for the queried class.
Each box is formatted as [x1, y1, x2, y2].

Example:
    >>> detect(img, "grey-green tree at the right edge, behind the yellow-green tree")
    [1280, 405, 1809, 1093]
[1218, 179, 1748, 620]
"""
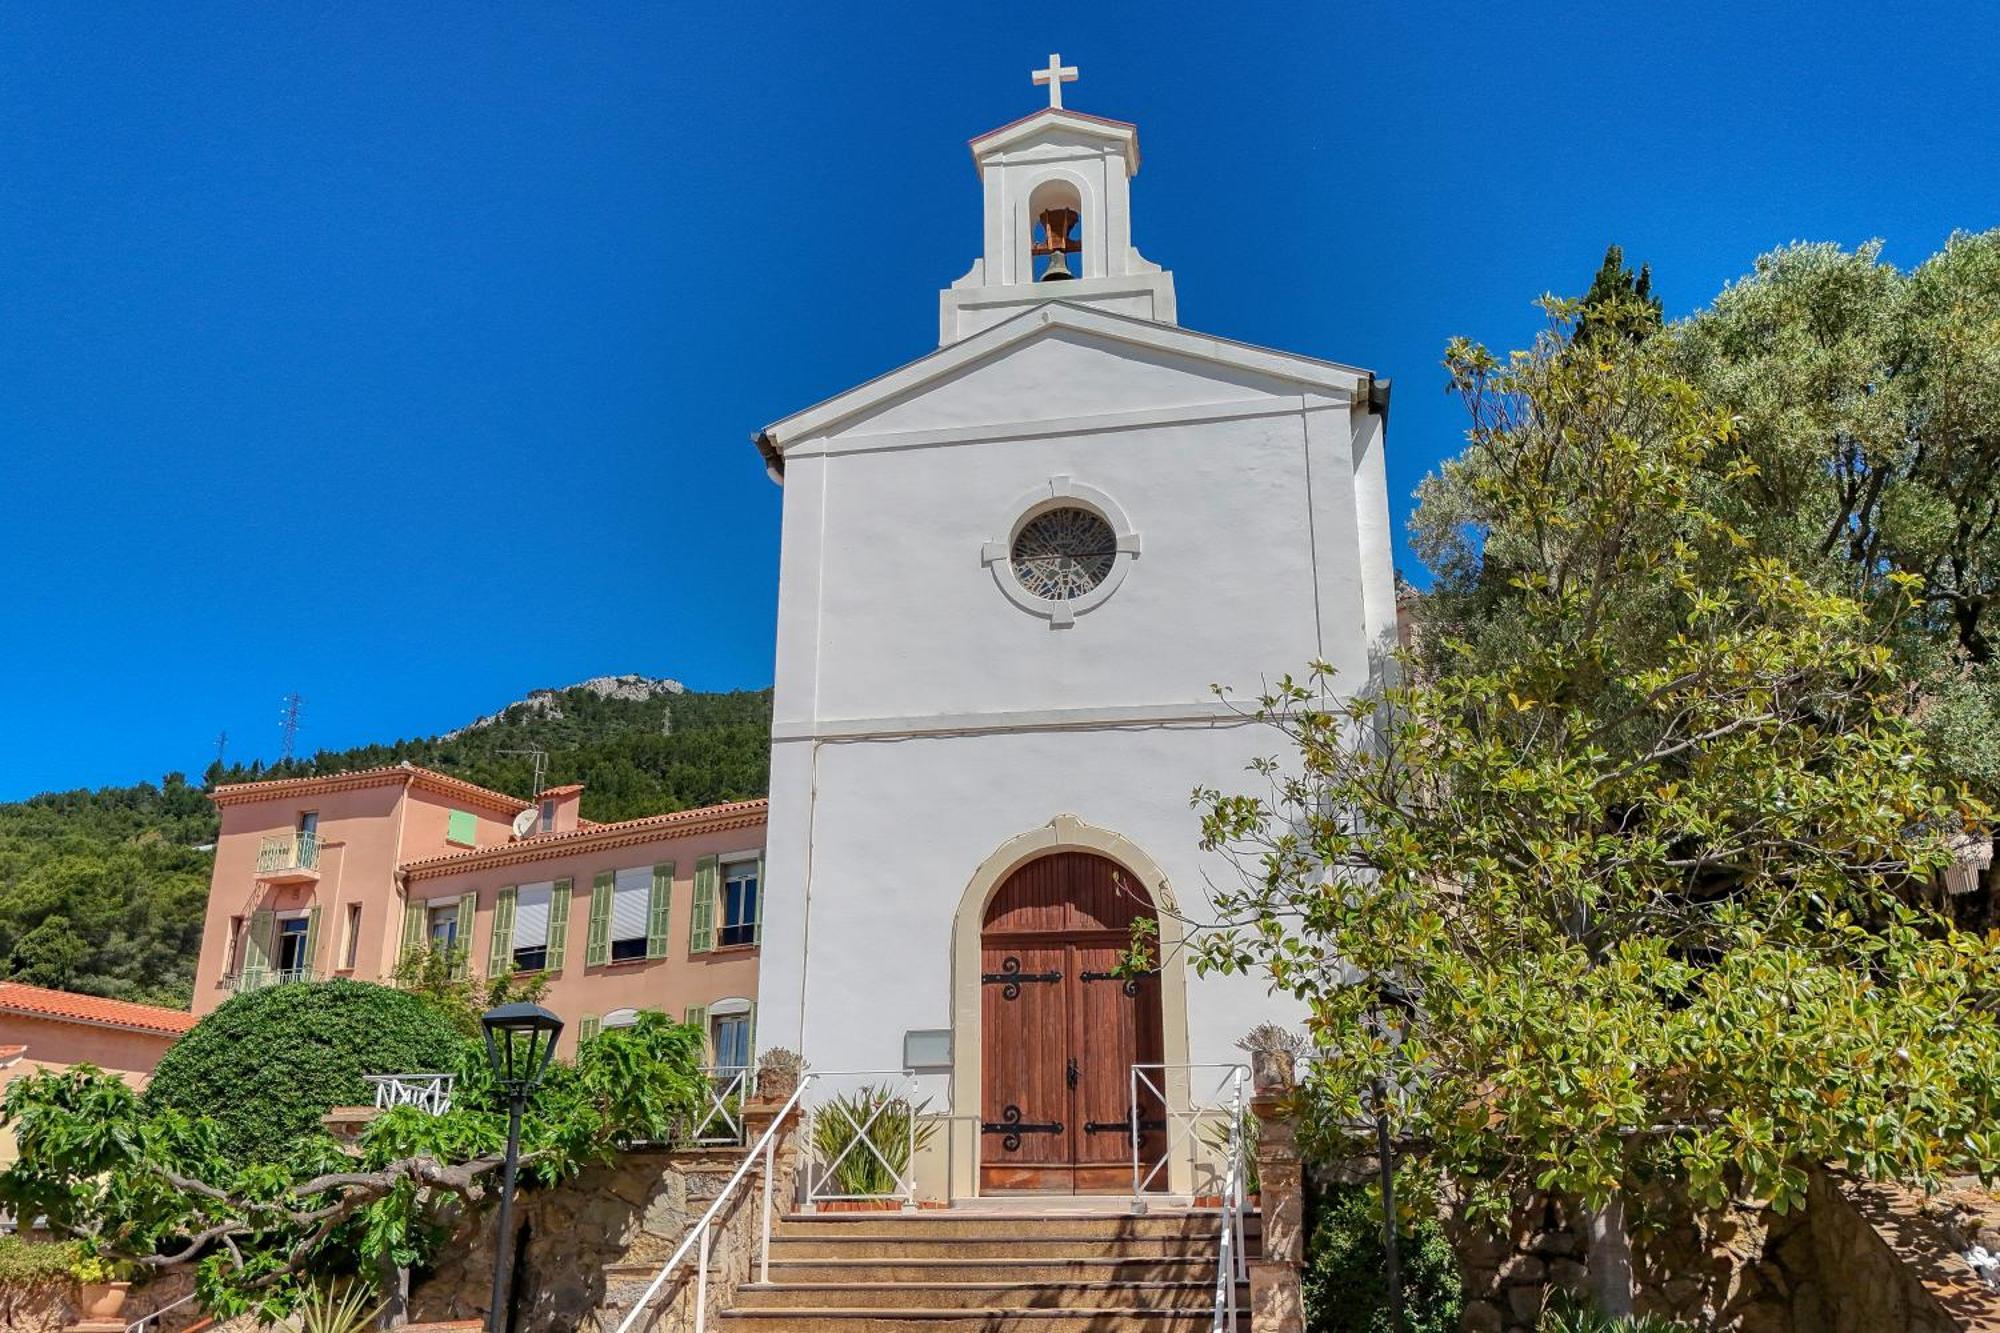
[1668, 230, 2000, 912]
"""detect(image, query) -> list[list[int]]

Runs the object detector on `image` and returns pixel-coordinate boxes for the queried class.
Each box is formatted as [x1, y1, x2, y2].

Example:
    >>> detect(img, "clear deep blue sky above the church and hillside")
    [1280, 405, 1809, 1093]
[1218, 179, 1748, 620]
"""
[0, 0, 2000, 799]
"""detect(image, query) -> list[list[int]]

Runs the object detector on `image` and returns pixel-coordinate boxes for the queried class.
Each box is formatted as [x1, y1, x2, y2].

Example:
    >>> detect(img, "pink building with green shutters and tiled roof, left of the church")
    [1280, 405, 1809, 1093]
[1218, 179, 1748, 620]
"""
[194, 765, 766, 1065]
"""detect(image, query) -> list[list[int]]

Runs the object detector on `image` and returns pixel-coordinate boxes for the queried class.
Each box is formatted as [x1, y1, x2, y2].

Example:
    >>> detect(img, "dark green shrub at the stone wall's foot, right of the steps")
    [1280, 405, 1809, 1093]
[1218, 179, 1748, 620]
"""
[1304, 1175, 1464, 1333]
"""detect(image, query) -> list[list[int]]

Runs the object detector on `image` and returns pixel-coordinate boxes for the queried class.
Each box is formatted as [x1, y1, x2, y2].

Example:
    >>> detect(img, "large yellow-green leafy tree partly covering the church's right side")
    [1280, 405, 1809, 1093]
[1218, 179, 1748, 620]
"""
[1198, 302, 2000, 1307]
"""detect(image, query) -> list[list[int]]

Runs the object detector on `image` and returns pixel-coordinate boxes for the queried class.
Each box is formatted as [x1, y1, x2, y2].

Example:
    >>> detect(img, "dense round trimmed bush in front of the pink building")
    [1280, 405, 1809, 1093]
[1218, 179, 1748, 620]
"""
[146, 981, 466, 1163]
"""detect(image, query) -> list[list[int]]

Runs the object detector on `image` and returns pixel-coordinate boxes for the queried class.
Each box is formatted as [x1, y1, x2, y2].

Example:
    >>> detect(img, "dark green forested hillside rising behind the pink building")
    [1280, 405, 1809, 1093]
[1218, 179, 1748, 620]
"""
[0, 687, 770, 1007]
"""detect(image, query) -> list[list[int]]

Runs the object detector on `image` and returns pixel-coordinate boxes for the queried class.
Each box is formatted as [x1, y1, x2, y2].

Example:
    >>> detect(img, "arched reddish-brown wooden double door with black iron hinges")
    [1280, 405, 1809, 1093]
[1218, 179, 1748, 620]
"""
[980, 853, 1166, 1195]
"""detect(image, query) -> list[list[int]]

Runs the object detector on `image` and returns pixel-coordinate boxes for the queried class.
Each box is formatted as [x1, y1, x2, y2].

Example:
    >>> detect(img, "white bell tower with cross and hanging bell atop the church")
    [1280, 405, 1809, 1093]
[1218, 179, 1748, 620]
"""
[938, 56, 1176, 346]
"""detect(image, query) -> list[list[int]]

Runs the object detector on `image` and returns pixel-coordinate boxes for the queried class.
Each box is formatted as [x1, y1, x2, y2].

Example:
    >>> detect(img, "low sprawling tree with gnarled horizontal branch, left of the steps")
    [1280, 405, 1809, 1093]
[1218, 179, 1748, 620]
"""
[0, 1008, 702, 1321]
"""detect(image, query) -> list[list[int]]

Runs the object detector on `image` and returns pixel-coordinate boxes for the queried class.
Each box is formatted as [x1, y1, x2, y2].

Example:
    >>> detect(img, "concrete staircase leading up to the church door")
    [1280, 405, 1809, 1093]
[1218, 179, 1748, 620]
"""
[716, 1209, 1258, 1333]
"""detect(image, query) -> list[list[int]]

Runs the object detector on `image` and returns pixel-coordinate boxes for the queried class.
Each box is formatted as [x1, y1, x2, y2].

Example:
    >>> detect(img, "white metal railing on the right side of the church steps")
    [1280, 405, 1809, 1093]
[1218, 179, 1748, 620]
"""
[1130, 1065, 1250, 1333]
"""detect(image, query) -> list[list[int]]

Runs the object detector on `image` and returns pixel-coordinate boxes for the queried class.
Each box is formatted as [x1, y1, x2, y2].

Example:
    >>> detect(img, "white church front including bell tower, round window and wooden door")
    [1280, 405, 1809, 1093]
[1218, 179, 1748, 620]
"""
[756, 60, 1396, 1199]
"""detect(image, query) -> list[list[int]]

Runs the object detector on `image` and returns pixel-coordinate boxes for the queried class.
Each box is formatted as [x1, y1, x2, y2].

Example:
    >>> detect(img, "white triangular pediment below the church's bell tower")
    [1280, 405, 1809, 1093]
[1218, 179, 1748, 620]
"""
[758, 302, 1372, 454]
